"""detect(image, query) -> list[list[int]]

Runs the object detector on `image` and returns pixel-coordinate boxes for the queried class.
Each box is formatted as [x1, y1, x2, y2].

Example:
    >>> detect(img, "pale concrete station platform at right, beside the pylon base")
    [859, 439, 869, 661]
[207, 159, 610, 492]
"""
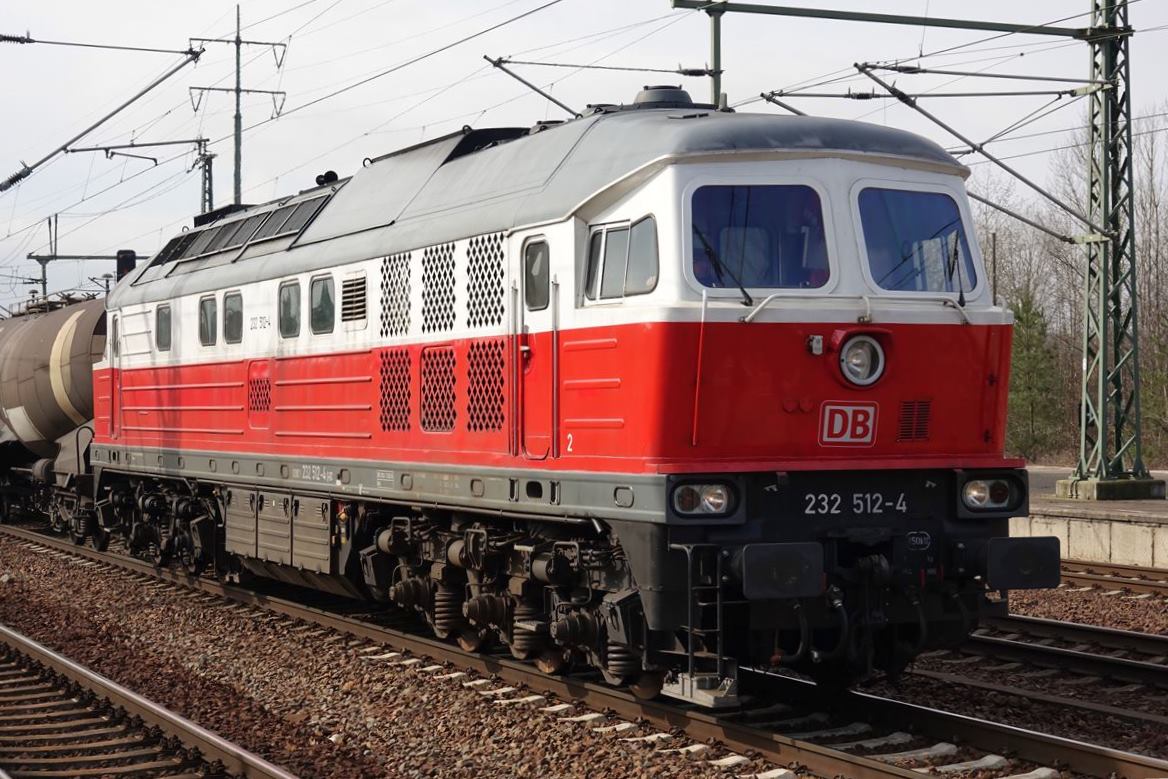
[1010, 466, 1168, 570]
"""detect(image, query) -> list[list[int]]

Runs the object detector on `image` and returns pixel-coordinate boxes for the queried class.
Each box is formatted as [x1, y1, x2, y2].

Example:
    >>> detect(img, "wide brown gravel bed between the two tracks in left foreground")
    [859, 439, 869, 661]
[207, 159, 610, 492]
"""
[0, 538, 771, 779]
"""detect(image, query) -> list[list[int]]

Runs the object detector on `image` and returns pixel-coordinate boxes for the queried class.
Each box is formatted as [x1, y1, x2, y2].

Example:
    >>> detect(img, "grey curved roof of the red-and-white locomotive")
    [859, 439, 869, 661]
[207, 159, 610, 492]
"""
[110, 109, 964, 306]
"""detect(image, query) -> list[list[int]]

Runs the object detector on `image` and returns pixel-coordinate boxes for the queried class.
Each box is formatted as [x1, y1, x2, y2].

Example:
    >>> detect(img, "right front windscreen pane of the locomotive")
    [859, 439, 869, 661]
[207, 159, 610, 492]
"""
[860, 187, 978, 292]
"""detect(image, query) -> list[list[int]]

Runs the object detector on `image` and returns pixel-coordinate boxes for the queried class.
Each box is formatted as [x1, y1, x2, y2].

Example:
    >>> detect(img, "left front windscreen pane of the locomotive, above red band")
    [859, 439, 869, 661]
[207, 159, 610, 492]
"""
[690, 185, 829, 290]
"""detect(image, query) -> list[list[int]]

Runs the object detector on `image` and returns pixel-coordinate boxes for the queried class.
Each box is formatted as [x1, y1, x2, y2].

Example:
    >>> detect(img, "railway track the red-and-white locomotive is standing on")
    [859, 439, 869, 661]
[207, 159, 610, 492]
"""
[0, 526, 1168, 779]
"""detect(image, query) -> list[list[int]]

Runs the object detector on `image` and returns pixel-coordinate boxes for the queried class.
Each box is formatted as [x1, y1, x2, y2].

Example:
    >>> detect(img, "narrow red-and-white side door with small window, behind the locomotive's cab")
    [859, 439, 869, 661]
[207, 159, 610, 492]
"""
[517, 237, 558, 460]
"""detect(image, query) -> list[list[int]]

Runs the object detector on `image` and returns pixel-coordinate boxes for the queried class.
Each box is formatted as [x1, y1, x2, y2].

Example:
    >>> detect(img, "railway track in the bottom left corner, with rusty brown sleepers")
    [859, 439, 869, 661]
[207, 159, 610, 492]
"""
[0, 611, 294, 779]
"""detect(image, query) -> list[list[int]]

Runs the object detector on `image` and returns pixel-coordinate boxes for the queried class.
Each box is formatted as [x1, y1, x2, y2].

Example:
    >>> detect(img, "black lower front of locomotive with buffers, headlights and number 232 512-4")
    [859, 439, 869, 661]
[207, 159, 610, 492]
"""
[618, 468, 1059, 705]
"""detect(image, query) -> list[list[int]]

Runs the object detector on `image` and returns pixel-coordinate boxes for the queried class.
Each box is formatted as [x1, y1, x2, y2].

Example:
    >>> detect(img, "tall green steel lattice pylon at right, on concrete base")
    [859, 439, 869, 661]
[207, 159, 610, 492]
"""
[1075, 0, 1148, 481]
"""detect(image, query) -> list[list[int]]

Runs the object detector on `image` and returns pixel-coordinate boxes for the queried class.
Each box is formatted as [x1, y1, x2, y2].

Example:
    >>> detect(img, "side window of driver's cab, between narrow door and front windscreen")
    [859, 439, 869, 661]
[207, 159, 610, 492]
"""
[584, 216, 659, 300]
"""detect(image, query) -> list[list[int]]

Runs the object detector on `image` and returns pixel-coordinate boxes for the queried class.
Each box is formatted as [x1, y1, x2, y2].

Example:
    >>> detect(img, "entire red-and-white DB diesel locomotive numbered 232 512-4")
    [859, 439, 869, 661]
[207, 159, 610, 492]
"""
[0, 88, 1059, 705]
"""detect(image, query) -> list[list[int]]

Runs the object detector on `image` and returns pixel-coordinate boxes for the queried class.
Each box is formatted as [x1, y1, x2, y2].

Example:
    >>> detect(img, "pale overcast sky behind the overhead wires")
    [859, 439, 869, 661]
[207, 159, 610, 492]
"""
[0, 0, 1168, 305]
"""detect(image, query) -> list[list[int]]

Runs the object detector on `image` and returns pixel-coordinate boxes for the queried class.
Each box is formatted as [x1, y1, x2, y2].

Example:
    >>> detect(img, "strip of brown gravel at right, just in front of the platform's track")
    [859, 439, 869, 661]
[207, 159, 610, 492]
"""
[1010, 587, 1168, 635]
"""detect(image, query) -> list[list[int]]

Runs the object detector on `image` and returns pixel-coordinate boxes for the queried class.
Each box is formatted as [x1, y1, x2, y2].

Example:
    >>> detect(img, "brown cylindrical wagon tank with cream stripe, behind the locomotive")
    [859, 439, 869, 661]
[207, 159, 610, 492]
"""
[0, 299, 105, 464]
